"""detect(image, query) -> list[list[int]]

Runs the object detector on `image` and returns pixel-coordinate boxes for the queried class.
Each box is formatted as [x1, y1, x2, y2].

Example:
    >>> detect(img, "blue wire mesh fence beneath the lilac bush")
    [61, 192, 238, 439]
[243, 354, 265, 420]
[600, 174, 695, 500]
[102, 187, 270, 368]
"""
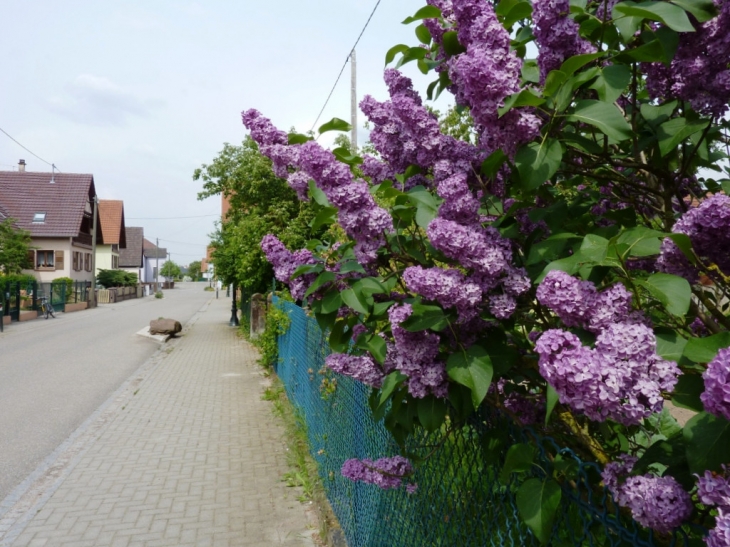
[274, 298, 701, 547]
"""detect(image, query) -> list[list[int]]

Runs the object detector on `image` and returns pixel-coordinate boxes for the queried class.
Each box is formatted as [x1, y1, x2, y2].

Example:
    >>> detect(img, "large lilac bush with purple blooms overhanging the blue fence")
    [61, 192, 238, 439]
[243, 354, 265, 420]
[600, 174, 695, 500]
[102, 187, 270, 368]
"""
[229, 0, 730, 545]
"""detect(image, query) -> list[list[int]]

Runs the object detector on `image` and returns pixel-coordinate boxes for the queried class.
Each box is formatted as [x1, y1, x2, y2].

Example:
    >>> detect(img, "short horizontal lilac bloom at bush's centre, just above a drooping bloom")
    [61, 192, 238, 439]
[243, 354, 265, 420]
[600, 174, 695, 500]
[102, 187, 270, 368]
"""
[403, 266, 484, 322]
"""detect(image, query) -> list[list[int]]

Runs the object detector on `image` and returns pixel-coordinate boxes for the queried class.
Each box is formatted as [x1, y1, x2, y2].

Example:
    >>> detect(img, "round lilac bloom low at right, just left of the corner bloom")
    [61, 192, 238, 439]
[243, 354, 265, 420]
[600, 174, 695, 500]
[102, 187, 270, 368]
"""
[602, 455, 692, 533]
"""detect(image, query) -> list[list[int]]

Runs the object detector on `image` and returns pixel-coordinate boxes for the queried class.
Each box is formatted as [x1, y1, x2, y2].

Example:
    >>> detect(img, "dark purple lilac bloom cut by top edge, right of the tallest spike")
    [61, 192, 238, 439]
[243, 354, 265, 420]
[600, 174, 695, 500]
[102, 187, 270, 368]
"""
[532, 0, 596, 82]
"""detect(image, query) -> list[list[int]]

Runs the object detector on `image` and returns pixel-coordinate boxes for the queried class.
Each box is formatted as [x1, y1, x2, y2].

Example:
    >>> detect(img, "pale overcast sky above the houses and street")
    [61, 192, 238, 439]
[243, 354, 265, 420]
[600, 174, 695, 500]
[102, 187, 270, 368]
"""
[0, 0, 446, 264]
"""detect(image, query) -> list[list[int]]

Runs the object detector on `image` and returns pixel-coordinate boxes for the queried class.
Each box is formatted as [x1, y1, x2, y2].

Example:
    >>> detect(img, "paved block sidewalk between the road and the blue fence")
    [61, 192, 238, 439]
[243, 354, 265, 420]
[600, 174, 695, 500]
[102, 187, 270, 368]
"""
[0, 299, 314, 547]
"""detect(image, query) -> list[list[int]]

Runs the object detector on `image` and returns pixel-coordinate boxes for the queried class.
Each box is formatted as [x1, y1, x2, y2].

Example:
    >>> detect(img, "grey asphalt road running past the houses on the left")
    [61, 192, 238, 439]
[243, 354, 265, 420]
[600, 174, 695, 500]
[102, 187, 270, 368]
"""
[0, 283, 216, 501]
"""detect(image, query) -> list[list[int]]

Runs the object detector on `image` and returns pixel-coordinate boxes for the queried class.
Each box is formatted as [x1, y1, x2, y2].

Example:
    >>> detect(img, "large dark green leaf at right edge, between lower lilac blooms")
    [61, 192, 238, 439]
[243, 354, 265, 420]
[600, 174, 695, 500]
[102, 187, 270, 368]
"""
[684, 412, 730, 473]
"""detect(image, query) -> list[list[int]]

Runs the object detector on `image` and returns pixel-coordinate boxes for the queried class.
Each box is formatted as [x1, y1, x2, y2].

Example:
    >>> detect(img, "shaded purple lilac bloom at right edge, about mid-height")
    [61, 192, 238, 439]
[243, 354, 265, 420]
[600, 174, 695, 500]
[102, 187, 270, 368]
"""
[657, 194, 730, 283]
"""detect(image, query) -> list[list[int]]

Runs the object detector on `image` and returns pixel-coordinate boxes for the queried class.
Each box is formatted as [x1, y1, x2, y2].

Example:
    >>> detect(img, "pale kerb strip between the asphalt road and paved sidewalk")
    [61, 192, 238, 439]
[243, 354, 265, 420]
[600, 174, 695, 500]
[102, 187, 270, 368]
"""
[0, 300, 212, 547]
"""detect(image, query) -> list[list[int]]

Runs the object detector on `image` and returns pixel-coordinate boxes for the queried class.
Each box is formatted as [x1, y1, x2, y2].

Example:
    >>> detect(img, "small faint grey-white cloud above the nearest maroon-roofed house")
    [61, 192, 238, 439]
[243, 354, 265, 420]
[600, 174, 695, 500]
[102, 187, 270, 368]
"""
[48, 74, 161, 126]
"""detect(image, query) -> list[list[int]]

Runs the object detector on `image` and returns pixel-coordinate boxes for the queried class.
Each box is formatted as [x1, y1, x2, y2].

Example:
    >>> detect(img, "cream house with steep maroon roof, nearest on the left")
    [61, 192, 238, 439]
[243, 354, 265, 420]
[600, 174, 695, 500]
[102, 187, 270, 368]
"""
[0, 164, 103, 283]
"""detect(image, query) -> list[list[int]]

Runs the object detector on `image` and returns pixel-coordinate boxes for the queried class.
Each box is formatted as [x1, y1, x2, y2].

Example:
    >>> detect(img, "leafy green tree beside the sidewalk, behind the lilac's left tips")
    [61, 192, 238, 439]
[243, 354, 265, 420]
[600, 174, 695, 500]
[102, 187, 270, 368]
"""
[193, 137, 315, 293]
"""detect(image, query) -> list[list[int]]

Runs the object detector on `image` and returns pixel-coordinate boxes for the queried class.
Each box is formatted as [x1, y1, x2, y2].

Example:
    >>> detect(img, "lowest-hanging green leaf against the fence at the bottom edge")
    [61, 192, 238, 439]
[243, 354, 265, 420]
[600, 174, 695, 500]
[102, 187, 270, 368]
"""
[517, 479, 563, 545]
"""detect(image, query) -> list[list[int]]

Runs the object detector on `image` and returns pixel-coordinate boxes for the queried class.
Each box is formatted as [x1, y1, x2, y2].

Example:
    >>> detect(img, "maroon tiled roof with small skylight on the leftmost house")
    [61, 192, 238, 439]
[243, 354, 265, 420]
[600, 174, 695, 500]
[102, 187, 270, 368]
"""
[0, 171, 96, 237]
